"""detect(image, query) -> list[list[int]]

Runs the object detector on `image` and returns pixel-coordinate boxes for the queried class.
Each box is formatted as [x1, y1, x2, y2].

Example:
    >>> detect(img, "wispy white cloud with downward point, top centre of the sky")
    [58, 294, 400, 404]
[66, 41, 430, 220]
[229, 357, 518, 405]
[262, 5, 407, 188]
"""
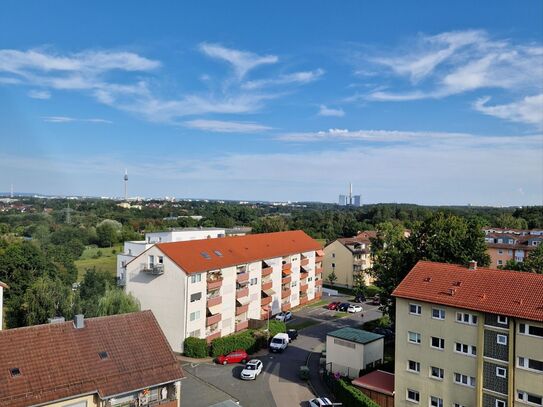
[200, 43, 279, 80]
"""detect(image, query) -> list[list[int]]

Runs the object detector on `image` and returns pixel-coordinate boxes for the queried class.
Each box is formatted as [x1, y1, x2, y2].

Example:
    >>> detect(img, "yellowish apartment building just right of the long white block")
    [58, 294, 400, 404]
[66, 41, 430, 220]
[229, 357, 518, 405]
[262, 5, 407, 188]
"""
[323, 231, 376, 288]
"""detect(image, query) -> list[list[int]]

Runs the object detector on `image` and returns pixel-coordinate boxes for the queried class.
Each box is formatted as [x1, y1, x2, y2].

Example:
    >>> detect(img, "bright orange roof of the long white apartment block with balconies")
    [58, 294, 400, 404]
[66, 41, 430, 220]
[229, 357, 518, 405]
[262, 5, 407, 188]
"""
[156, 230, 322, 273]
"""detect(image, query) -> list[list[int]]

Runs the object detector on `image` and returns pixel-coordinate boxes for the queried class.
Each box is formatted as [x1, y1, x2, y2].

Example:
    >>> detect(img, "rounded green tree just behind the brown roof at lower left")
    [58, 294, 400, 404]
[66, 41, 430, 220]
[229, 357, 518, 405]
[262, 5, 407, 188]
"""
[22, 277, 73, 325]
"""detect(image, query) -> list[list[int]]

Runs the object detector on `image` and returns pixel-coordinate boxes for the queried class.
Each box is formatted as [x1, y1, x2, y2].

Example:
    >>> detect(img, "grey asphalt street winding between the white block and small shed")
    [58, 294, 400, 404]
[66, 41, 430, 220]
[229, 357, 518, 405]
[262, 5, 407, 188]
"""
[181, 296, 381, 407]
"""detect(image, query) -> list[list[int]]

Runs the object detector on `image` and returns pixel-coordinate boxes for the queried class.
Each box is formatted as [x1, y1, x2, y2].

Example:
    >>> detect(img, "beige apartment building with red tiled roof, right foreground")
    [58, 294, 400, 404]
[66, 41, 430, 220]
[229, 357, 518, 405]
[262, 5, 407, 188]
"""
[393, 261, 543, 407]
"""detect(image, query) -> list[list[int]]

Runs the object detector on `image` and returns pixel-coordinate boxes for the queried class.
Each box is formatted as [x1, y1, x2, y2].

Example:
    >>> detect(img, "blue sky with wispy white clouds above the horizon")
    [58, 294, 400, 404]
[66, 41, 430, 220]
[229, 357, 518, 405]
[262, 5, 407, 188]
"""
[0, 0, 543, 205]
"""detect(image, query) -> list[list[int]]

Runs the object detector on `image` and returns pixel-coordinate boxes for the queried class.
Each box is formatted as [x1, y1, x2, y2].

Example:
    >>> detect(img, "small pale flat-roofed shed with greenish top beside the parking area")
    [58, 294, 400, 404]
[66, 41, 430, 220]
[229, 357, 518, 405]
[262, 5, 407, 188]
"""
[326, 327, 384, 379]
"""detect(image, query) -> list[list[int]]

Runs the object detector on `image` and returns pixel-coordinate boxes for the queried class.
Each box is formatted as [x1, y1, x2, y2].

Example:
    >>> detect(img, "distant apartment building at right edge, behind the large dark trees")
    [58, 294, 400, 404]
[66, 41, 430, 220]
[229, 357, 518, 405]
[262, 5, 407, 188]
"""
[483, 228, 543, 268]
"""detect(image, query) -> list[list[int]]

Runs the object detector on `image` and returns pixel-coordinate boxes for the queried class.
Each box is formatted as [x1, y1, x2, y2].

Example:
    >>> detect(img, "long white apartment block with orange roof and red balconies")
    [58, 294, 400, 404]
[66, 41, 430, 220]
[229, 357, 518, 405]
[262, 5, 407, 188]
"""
[125, 231, 324, 352]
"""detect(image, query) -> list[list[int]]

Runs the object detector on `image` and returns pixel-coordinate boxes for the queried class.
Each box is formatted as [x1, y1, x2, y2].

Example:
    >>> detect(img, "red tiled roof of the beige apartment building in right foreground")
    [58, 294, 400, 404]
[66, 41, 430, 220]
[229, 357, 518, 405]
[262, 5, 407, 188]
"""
[392, 261, 543, 321]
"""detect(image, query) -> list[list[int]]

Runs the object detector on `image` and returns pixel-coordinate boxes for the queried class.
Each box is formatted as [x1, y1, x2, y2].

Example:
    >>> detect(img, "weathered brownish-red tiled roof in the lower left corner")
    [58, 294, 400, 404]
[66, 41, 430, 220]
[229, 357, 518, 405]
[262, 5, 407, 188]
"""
[0, 311, 183, 407]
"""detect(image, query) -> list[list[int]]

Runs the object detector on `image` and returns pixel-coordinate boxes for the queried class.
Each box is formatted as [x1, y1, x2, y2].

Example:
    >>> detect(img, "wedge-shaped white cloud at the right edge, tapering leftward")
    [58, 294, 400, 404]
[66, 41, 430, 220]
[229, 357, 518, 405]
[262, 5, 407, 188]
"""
[473, 93, 543, 128]
